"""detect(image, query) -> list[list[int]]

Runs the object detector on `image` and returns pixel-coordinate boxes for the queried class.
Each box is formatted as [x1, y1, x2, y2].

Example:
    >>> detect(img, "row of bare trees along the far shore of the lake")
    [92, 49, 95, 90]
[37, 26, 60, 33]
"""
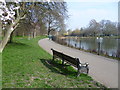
[68, 19, 118, 37]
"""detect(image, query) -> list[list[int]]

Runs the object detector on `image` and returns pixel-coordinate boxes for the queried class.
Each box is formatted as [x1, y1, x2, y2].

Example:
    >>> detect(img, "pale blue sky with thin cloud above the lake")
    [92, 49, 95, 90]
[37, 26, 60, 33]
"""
[67, 0, 118, 30]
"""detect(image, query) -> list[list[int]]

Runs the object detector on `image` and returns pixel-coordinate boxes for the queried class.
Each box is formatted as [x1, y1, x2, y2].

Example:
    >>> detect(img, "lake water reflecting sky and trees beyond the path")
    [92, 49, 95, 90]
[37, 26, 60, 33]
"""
[65, 38, 120, 56]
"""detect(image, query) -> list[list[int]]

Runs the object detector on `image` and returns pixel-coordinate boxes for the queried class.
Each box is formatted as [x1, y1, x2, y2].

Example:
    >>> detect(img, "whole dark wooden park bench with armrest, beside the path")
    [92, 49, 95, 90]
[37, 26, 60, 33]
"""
[51, 49, 89, 76]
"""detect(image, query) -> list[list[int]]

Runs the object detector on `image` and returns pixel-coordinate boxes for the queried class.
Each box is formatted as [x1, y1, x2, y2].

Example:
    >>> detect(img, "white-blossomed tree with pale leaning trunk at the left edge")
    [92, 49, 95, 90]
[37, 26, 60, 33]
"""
[0, 0, 25, 52]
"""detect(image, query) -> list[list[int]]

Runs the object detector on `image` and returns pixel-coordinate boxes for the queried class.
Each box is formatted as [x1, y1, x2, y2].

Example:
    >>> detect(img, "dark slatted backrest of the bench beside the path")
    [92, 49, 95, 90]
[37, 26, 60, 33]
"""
[51, 49, 80, 67]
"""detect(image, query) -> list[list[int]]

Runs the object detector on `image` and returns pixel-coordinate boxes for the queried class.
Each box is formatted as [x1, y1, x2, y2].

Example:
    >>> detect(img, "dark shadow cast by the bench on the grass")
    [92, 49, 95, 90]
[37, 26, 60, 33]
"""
[40, 59, 77, 76]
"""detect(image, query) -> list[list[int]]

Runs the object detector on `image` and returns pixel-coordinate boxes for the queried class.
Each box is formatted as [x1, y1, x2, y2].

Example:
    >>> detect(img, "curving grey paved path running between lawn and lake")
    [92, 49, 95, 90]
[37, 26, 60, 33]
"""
[38, 39, 118, 88]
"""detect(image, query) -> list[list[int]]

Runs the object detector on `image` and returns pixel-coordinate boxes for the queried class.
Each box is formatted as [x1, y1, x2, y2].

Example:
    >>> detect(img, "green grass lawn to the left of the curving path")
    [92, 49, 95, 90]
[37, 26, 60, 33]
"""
[2, 36, 105, 88]
